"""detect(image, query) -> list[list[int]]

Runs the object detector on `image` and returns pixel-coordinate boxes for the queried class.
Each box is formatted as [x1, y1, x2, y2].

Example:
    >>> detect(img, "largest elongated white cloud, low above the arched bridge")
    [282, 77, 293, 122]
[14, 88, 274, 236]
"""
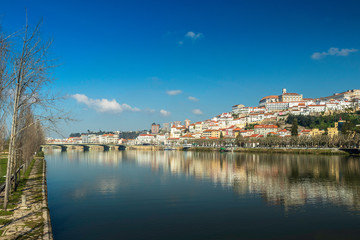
[71, 93, 140, 113]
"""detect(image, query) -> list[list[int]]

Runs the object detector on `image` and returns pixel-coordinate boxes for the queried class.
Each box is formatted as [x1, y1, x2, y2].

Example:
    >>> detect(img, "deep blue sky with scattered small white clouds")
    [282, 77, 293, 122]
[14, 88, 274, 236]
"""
[0, 0, 360, 135]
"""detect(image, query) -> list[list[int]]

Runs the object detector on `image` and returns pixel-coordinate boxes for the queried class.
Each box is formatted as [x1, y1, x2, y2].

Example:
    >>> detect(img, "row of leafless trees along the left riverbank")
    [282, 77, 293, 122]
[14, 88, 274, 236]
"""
[0, 19, 69, 209]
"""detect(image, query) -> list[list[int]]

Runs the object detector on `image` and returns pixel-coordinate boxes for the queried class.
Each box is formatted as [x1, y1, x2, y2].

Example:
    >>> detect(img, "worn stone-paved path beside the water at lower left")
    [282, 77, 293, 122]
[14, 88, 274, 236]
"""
[0, 158, 51, 239]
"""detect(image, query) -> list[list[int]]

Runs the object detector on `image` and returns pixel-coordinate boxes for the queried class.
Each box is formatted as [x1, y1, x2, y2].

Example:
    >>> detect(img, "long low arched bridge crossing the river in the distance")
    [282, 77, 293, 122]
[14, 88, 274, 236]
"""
[41, 143, 126, 152]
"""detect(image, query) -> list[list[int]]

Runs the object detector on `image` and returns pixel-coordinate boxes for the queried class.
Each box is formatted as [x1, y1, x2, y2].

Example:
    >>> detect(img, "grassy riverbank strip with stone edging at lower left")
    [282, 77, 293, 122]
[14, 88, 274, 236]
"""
[0, 157, 53, 239]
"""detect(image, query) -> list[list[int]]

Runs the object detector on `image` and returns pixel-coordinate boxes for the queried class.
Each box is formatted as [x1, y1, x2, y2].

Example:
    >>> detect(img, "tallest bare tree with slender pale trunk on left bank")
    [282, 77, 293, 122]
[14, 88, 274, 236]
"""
[4, 18, 68, 209]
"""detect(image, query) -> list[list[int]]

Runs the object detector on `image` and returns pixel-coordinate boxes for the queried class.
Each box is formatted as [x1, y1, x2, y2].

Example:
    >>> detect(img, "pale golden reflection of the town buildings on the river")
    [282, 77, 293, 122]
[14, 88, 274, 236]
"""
[46, 150, 360, 211]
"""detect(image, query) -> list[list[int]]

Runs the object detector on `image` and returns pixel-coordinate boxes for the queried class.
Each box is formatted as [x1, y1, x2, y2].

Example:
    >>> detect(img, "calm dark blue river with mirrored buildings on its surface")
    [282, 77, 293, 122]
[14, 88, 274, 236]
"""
[45, 150, 360, 240]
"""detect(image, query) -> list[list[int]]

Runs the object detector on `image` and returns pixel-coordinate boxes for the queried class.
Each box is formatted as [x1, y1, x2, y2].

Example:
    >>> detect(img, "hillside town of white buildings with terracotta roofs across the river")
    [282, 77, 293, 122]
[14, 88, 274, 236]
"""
[48, 88, 360, 146]
